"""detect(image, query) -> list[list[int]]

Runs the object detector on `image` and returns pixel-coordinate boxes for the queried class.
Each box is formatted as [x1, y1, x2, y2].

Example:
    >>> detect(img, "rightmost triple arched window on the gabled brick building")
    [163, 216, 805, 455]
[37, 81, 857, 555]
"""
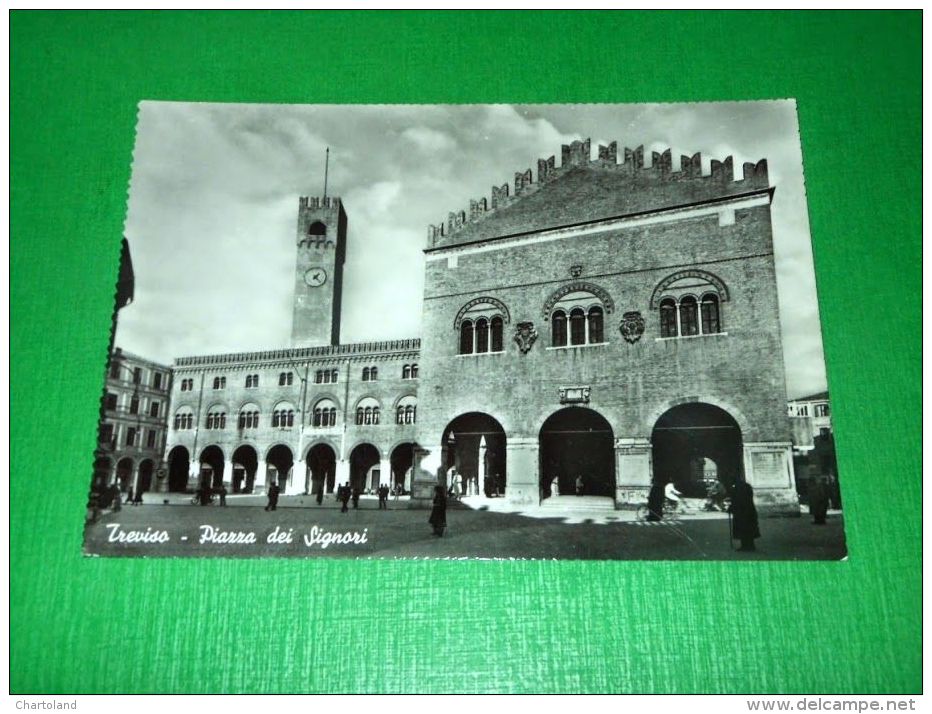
[652, 270, 728, 337]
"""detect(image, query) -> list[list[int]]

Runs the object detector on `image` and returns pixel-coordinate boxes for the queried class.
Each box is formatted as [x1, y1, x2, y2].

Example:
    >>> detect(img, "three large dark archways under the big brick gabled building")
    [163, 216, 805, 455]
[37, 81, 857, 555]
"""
[442, 402, 744, 498]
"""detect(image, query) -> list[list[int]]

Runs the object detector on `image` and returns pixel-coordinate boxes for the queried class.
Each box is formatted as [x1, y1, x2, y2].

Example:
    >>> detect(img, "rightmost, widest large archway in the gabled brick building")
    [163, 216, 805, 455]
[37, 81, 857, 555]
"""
[651, 402, 744, 498]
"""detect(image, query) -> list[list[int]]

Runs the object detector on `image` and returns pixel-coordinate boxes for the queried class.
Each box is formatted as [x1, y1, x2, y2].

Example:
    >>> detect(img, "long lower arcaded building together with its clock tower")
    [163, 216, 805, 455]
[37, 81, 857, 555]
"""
[163, 198, 420, 493]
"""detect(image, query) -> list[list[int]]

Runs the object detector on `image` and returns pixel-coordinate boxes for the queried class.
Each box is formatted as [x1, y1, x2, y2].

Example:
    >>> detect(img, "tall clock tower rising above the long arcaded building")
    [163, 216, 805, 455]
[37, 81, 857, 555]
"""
[291, 196, 346, 347]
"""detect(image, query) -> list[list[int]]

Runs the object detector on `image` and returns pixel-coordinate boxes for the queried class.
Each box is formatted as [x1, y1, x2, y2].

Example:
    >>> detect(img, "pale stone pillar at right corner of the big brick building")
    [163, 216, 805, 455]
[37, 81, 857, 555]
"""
[744, 441, 799, 515]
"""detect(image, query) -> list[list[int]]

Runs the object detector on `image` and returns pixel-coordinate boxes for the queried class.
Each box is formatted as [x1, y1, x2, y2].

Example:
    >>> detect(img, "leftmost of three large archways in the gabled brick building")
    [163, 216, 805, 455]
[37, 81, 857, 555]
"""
[442, 412, 507, 494]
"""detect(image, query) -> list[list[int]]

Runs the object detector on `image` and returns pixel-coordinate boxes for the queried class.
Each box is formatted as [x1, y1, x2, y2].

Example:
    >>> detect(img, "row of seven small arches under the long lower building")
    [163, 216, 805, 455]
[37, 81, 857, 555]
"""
[168, 442, 415, 494]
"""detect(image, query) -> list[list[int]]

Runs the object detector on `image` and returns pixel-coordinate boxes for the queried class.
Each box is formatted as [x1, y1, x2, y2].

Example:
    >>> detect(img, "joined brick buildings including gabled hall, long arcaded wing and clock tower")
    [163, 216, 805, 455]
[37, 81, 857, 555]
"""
[166, 140, 797, 509]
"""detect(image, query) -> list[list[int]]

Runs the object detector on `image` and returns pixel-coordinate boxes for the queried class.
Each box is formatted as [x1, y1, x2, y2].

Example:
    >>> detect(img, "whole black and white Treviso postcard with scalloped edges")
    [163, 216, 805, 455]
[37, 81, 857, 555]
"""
[85, 100, 846, 560]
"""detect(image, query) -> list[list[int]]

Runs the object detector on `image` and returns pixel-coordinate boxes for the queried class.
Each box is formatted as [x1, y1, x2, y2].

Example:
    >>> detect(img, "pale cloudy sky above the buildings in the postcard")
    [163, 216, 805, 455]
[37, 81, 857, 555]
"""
[117, 101, 826, 397]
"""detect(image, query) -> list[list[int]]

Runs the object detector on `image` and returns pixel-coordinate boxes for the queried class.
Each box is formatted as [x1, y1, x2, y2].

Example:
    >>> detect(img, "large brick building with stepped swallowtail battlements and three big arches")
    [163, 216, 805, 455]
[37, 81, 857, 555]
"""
[417, 141, 797, 510]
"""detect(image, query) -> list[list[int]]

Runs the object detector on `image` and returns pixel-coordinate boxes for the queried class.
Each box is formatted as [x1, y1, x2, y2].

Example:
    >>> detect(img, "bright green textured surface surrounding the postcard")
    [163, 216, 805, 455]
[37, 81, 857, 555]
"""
[10, 12, 922, 693]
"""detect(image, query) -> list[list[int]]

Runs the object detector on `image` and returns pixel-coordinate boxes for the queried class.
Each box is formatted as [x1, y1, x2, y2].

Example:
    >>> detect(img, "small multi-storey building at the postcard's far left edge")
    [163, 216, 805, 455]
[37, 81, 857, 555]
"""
[95, 347, 172, 492]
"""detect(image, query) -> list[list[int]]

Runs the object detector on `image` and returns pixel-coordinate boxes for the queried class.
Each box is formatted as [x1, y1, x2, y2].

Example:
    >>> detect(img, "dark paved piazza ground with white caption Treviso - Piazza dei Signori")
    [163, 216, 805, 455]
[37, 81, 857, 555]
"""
[85, 496, 846, 560]
